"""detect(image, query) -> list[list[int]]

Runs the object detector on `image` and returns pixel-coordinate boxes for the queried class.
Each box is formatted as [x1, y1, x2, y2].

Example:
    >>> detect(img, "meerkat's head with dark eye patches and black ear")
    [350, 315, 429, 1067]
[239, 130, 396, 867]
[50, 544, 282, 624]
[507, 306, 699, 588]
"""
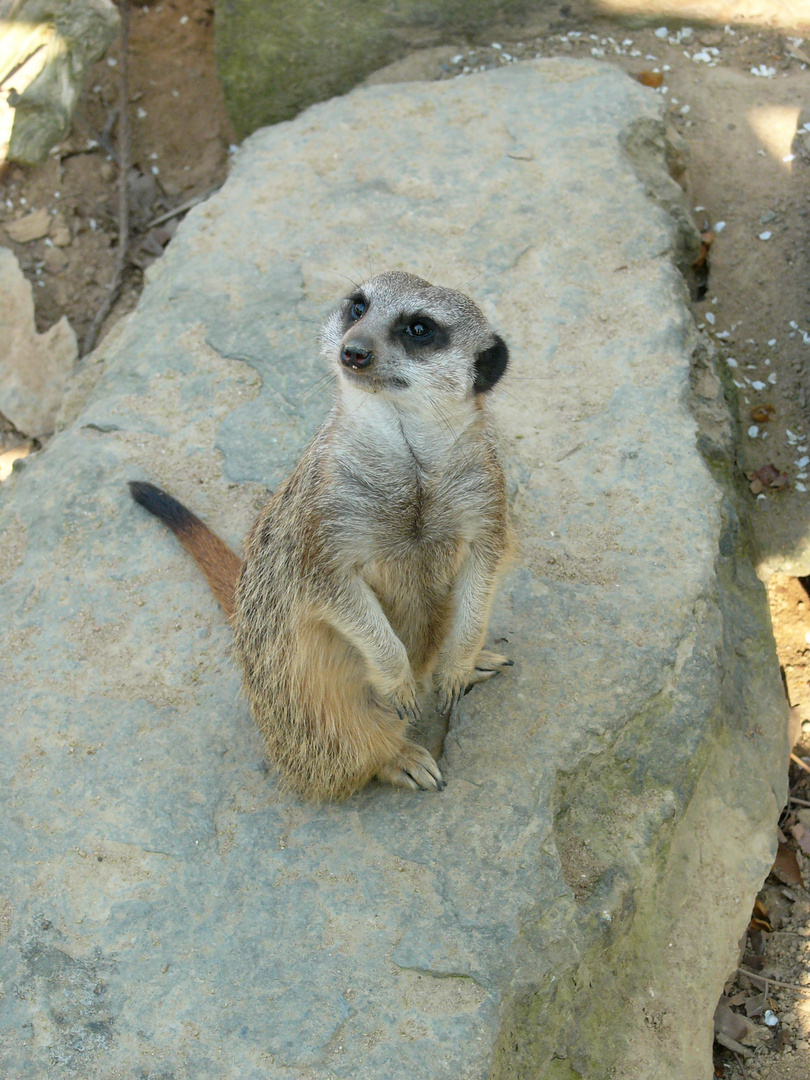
[321, 271, 509, 404]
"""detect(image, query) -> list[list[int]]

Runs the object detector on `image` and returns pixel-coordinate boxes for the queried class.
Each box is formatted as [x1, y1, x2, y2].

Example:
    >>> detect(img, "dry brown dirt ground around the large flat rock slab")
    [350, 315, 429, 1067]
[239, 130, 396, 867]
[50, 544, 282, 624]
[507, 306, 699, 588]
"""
[0, 0, 810, 1080]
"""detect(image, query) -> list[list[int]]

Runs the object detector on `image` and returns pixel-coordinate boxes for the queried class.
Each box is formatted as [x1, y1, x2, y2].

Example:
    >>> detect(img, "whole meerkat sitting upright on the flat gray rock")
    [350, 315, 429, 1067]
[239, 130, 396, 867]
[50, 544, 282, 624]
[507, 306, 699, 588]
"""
[130, 272, 511, 800]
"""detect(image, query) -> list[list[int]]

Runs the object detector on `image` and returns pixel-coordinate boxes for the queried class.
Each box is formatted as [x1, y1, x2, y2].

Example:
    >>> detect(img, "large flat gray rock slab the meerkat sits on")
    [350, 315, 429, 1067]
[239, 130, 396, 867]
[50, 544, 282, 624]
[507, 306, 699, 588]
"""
[0, 62, 786, 1080]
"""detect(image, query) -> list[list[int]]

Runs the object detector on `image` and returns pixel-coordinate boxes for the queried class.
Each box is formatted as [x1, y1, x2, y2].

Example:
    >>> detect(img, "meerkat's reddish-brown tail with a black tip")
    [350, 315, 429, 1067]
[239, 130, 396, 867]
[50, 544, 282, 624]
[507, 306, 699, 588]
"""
[130, 480, 242, 619]
